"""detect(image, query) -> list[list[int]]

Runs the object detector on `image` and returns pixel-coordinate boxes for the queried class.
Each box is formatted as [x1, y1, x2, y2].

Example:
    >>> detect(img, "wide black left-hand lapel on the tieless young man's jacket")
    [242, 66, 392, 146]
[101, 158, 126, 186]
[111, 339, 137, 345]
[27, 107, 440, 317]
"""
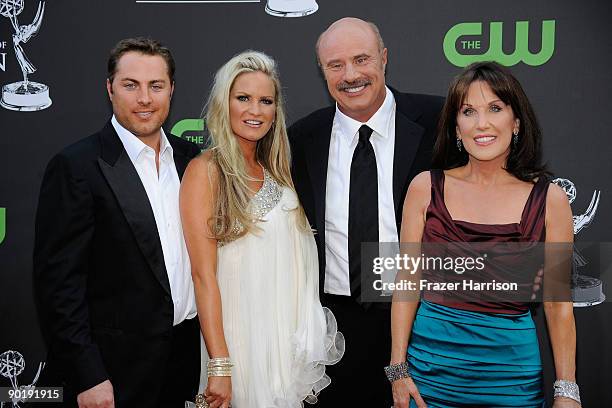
[98, 122, 172, 294]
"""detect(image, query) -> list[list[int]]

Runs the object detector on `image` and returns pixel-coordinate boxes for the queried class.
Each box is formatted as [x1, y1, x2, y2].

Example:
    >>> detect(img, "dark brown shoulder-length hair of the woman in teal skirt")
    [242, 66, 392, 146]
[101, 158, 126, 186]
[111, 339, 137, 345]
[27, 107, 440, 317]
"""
[433, 61, 550, 182]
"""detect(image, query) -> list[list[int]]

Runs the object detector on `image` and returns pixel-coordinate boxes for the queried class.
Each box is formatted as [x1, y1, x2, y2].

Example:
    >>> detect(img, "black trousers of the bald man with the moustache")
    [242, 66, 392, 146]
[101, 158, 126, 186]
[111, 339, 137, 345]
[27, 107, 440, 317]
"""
[317, 294, 393, 408]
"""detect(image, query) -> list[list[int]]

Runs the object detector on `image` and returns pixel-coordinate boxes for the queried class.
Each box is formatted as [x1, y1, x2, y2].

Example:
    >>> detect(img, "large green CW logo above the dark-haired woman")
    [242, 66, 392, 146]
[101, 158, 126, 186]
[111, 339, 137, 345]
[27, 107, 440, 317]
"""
[443, 20, 555, 67]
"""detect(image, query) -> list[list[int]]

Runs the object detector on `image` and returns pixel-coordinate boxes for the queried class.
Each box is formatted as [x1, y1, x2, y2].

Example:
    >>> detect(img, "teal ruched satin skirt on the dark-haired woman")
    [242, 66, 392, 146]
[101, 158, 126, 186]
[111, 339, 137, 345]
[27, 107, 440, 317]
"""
[408, 300, 544, 408]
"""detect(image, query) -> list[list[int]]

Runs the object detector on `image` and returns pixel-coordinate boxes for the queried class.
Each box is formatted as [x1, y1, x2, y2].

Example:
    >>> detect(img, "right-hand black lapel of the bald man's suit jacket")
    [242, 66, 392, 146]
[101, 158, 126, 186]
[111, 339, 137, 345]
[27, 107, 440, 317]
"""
[392, 89, 425, 226]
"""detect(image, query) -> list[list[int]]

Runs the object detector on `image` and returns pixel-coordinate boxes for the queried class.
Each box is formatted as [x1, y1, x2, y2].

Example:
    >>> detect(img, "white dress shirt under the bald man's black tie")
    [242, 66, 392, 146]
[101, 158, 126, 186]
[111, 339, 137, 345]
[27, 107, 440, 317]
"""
[323, 88, 398, 296]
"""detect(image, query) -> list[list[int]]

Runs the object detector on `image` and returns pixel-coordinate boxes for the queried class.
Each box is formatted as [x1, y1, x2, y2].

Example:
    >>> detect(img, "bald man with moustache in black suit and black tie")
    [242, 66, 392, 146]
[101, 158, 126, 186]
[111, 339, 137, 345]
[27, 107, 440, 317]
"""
[289, 18, 443, 408]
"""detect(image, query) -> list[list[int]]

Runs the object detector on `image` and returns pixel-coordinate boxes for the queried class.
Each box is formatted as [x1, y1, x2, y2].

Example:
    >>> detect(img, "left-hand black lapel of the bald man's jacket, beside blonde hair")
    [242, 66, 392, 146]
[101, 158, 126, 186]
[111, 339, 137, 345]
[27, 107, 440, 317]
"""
[306, 111, 334, 237]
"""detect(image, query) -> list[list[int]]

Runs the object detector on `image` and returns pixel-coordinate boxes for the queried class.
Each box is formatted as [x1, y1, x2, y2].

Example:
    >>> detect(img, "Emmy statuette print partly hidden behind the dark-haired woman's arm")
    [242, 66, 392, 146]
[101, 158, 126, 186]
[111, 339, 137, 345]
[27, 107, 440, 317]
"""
[553, 178, 606, 307]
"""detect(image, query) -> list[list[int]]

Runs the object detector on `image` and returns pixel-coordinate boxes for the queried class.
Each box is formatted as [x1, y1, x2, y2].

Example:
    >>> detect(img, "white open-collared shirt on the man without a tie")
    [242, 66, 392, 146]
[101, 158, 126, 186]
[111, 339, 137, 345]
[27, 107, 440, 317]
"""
[111, 115, 196, 326]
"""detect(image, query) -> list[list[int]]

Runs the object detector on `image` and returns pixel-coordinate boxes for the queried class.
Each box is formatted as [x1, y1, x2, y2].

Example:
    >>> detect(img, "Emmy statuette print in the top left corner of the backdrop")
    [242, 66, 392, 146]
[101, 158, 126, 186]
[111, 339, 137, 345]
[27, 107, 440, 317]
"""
[0, 0, 51, 111]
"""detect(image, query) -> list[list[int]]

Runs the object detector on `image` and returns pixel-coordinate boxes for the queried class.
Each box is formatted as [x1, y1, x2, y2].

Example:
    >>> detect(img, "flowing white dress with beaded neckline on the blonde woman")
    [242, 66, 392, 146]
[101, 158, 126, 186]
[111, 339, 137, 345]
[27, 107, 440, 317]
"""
[203, 170, 344, 408]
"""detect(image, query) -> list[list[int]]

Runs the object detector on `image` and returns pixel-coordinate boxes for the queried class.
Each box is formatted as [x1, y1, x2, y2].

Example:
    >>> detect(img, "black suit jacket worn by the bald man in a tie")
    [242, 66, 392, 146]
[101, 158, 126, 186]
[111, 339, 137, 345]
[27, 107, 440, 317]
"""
[289, 89, 444, 293]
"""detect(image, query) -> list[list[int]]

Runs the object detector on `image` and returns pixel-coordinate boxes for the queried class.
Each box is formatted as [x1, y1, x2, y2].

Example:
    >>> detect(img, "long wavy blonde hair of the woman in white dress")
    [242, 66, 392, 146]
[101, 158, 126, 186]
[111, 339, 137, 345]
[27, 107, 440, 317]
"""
[205, 50, 308, 241]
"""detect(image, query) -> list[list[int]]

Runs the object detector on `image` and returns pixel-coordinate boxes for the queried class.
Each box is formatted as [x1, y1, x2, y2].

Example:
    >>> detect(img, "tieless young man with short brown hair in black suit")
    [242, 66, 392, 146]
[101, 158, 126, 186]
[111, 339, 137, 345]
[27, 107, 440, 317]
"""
[34, 38, 200, 408]
